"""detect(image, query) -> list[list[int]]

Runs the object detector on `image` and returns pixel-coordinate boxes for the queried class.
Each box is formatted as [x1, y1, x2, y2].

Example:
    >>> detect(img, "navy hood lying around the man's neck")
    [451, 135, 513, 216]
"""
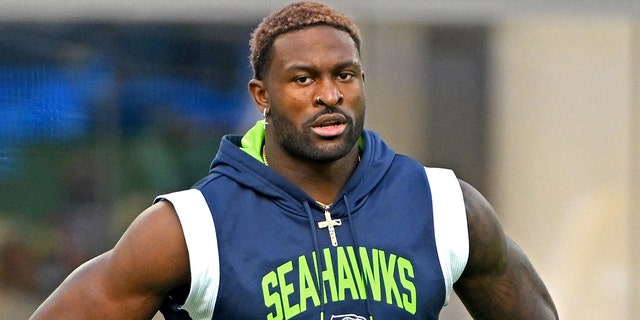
[210, 125, 395, 217]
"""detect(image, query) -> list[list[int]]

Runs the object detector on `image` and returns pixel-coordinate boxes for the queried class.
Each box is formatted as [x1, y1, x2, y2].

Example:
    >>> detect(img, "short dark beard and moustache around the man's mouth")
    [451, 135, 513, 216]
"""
[270, 108, 364, 163]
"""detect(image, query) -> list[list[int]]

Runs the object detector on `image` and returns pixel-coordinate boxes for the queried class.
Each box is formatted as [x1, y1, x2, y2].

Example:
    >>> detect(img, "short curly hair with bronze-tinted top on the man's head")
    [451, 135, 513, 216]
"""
[249, 1, 361, 79]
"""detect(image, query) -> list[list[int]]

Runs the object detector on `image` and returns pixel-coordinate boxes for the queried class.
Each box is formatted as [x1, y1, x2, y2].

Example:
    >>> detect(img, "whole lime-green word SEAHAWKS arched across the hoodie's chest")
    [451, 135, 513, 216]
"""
[261, 246, 418, 320]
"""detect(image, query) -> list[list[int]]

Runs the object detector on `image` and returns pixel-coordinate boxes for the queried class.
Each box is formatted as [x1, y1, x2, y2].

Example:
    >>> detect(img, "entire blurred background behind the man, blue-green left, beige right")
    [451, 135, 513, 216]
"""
[0, 0, 640, 320]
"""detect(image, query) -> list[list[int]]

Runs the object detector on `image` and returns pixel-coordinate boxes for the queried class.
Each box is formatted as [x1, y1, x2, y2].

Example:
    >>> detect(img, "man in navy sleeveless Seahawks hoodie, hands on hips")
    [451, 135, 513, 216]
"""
[33, 2, 557, 320]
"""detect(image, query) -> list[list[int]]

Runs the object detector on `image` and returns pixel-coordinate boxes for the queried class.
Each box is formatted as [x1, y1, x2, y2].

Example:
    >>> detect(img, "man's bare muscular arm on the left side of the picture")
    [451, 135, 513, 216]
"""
[31, 201, 189, 320]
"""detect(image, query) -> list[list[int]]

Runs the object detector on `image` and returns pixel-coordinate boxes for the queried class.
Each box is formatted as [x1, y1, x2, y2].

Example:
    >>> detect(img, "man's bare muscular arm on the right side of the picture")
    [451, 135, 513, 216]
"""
[454, 182, 558, 320]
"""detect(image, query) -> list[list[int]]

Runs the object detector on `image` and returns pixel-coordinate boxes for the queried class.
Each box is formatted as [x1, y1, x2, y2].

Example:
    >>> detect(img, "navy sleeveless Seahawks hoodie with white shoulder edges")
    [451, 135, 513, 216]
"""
[156, 126, 469, 320]
